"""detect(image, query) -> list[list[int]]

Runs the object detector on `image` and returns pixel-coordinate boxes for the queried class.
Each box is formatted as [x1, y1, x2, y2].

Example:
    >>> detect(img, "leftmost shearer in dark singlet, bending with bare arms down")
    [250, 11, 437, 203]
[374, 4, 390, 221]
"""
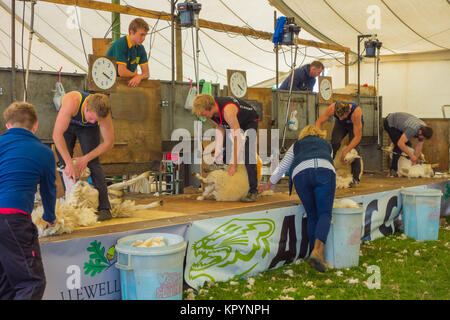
[53, 91, 114, 221]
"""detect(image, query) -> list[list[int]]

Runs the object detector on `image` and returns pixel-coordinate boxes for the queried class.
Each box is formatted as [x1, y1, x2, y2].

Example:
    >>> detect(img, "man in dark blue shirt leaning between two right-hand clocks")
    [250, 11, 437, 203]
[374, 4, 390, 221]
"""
[278, 61, 324, 91]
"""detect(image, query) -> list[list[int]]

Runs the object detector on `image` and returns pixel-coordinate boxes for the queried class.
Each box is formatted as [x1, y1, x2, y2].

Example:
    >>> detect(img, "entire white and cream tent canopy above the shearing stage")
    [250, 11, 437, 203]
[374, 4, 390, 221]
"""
[0, 0, 450, 85]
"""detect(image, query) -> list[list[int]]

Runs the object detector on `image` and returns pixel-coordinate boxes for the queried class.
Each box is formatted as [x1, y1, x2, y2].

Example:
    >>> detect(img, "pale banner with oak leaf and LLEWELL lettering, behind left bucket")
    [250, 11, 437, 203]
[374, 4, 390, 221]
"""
[40, 224, 189, 300]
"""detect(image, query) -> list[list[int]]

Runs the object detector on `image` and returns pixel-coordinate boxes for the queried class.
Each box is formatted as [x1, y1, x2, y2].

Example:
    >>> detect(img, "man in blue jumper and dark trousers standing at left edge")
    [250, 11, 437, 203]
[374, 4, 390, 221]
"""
[0, 102, 56, 300]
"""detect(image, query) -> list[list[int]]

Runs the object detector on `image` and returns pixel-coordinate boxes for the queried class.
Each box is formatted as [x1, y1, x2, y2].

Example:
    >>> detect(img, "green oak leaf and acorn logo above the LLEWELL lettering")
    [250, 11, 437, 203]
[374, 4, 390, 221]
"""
[83, 240, 116, 277]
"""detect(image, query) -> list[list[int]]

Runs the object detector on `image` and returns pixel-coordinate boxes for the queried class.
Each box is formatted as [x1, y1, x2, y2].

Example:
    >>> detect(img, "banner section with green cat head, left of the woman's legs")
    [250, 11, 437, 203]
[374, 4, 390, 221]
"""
[184, 206, 308, 288]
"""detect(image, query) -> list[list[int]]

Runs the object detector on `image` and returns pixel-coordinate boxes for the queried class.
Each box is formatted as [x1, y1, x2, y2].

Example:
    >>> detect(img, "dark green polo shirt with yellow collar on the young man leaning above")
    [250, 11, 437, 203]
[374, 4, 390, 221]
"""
[106, 35, 148, 72]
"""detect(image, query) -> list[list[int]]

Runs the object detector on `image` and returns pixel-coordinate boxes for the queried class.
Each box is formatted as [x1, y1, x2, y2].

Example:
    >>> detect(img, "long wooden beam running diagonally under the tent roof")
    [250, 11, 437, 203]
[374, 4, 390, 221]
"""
[41, 0, 350, 52]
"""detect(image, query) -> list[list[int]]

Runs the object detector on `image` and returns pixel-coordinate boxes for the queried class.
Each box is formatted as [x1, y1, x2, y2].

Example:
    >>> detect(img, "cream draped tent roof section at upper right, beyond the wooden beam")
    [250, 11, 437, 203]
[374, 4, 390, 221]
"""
[270, 0, 450, 54]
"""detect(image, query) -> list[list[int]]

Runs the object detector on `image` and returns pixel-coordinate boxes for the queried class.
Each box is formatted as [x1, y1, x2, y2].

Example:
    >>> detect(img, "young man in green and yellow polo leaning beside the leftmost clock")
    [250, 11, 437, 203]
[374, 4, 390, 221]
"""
[106, 18, 150, 87]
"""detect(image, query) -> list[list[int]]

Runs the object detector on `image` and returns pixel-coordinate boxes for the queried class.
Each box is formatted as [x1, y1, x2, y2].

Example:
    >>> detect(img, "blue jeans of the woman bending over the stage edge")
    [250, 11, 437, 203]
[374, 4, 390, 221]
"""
[293, 168, 336, 252]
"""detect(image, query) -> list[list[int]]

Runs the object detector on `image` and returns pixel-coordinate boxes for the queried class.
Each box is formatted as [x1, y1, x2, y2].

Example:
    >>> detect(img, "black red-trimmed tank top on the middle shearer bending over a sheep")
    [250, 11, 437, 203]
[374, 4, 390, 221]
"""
[211, 97, 259, 130]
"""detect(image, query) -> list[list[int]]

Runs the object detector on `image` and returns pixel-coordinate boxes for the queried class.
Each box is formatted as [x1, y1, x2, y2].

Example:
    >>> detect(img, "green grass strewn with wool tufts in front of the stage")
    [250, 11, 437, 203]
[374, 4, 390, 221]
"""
[184, 216, 450, 300]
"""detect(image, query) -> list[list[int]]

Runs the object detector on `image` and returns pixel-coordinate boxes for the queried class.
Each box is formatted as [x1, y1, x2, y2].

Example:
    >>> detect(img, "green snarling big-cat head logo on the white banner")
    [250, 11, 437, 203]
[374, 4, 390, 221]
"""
[189, 219, 275, 281]
